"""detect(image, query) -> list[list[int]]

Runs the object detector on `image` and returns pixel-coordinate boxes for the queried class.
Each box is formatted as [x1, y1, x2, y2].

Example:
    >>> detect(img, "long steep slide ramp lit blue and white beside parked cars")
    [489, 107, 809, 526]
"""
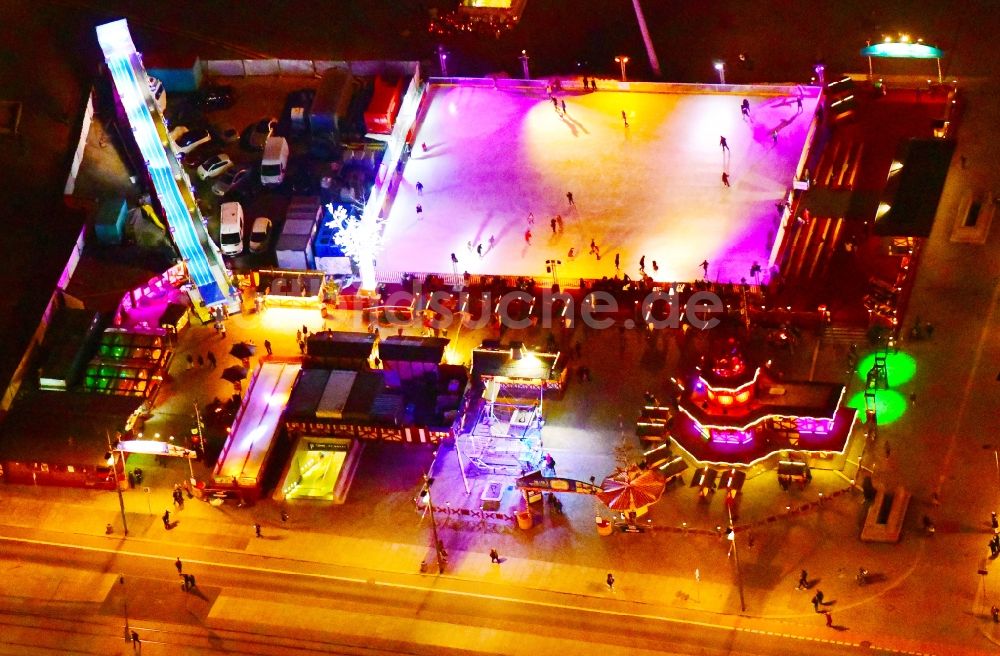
[97, 20, 230, 306]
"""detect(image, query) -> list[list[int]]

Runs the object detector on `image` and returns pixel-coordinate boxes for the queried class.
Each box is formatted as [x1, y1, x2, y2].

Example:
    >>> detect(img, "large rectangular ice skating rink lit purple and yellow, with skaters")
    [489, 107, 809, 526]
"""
[378, 82, 818, 282]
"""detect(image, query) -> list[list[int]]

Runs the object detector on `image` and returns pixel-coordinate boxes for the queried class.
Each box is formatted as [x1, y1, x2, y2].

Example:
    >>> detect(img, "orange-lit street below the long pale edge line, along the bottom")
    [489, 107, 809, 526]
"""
[0, 539, 892, 656]
